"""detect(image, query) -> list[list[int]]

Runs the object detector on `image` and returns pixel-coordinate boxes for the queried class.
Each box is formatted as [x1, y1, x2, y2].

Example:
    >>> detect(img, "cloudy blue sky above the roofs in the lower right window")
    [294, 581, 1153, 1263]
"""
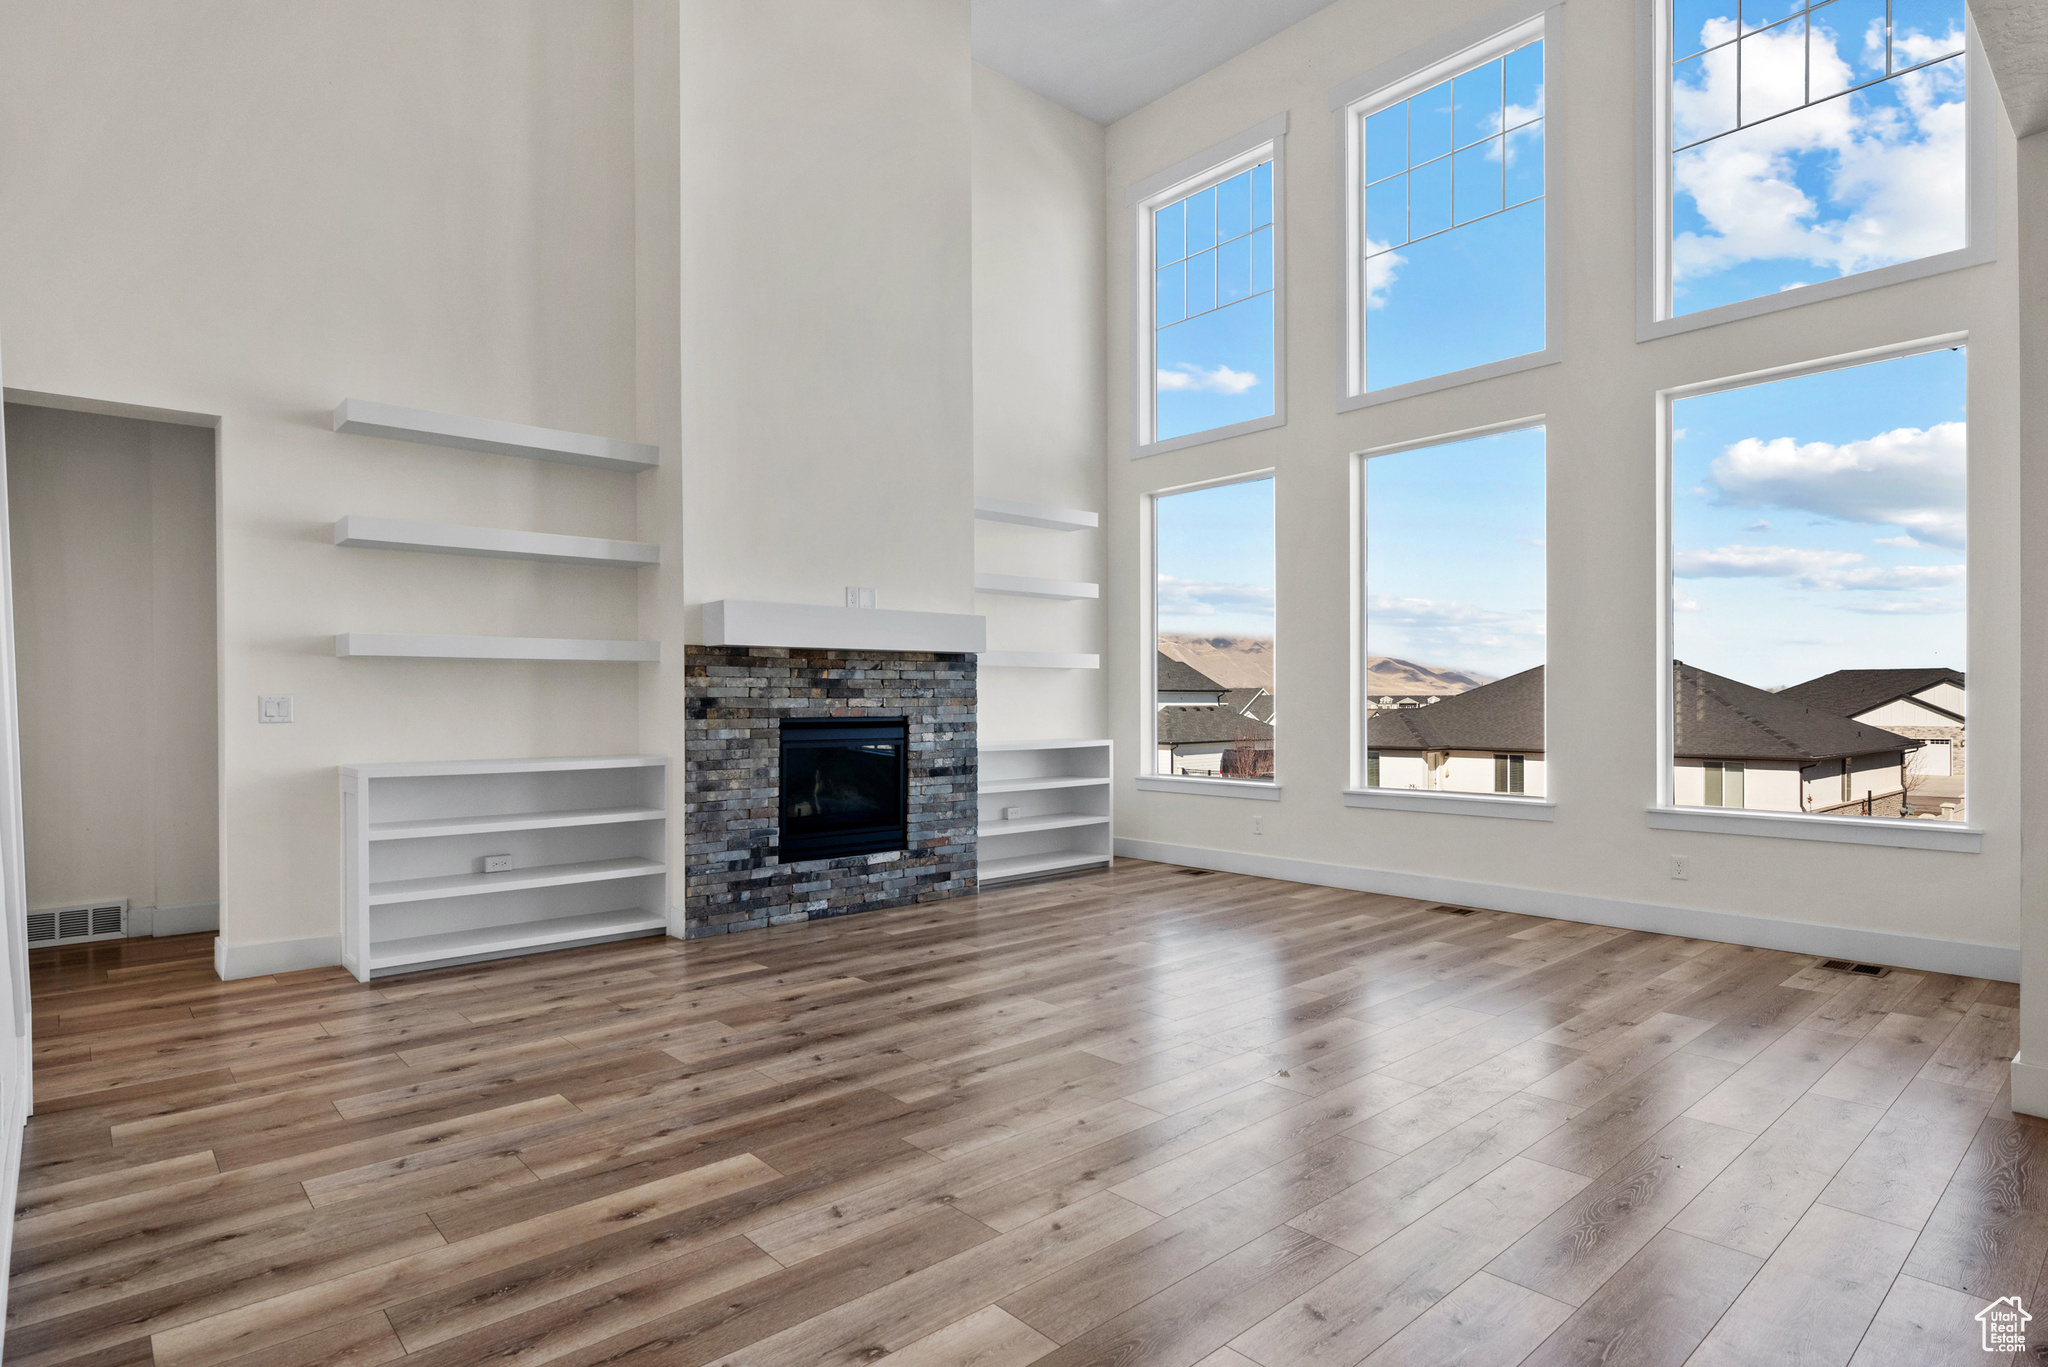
[1671, 348, 1966, 689]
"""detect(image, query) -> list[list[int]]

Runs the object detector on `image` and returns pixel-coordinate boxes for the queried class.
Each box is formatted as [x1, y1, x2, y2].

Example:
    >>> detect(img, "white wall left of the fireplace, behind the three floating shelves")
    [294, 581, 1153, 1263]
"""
[0, 0, 643, 967]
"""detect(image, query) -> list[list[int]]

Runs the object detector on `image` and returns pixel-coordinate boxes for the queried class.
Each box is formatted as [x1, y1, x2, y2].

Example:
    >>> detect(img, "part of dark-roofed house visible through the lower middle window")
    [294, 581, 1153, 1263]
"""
[1366, 666, 1544, 797]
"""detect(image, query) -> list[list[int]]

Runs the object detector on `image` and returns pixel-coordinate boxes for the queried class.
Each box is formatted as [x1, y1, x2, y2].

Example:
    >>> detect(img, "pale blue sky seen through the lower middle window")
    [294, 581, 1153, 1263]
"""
[1366, 426, 1544, 676]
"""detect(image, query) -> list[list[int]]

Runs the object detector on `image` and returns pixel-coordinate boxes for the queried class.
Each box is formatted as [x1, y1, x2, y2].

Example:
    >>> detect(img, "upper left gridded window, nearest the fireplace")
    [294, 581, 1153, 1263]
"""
[1133, 119, 1284, 455]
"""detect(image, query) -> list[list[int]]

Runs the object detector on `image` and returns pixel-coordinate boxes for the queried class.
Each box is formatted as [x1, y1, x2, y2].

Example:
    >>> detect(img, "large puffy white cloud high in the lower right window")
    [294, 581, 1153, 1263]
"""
[1708, 422, 1968, 549]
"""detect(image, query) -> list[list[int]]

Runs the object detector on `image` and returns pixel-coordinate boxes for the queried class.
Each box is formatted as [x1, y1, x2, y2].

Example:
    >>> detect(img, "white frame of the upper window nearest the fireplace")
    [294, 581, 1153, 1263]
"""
[1124, 113, 1286, 459]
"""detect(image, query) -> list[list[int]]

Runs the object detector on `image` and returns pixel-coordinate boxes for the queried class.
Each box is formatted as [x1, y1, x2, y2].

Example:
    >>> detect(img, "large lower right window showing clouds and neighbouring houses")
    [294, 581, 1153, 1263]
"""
[1667, 348, 1968, 822]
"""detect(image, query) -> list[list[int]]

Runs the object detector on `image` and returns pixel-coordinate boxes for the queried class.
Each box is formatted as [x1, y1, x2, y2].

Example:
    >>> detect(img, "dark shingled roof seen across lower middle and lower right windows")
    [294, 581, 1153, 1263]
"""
[1368, 662, 1919, 764]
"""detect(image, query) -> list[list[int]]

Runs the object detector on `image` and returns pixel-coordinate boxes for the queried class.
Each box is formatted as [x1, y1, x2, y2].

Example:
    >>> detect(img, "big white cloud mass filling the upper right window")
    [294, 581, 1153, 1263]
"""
[1671, 20, 1964, 283]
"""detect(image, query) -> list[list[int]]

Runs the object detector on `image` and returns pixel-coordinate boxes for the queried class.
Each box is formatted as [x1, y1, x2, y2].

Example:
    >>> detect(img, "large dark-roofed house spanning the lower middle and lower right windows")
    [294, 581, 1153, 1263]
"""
[1366, 662, 1917, 816]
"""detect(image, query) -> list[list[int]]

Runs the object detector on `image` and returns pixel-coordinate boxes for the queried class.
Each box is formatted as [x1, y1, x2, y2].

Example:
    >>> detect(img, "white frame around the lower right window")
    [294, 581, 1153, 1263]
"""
[1654, 332, 1985, 855]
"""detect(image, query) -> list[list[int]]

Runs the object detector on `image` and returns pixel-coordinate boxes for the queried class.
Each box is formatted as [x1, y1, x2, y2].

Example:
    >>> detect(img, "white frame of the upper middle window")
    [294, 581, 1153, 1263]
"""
[1329, 0, 1563, 412]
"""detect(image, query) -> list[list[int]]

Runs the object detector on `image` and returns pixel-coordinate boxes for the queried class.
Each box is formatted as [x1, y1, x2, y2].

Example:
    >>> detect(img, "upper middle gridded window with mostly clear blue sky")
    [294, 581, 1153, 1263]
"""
[1337, 12, 1550, 408]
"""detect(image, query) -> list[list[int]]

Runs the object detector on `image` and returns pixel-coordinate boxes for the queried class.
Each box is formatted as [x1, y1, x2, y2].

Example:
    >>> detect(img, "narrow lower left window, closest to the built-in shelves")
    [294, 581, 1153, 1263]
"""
[1153, 478, 1280, 783]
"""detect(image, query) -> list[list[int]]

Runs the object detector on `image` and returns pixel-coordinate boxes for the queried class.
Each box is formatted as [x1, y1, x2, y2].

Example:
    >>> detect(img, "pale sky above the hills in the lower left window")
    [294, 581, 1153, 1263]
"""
[1155, 480, 1274, 639]
